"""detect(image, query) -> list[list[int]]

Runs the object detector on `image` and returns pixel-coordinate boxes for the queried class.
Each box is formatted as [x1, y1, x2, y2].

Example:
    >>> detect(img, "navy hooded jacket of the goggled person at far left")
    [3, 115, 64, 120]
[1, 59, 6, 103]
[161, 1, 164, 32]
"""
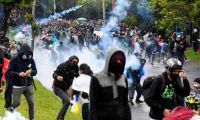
[6, 44, 37, 86]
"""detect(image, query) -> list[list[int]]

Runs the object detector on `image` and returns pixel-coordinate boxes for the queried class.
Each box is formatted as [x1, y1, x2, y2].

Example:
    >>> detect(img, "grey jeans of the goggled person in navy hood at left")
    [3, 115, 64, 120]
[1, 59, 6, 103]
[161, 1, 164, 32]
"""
[12, 86, 34, 120]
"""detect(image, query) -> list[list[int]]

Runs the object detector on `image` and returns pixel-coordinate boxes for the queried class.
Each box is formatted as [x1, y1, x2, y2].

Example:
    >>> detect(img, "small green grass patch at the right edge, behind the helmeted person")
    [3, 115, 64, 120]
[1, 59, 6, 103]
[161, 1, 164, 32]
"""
[185, 48, 200, 62]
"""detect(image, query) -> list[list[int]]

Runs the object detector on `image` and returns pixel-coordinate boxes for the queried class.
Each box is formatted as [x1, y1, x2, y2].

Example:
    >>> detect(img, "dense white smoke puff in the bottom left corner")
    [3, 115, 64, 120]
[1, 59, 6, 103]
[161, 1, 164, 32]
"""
[0, 111, 27, 120]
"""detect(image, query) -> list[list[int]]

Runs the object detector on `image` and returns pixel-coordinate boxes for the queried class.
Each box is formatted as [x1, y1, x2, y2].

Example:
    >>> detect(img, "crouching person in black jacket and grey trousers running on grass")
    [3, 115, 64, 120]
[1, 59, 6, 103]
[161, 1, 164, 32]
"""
[53, 56, 79, 120]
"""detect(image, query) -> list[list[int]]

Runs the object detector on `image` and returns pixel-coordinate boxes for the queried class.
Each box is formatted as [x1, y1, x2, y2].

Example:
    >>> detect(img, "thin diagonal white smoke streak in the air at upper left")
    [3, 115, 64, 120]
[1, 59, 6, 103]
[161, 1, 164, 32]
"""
[38, 5, 82, 25]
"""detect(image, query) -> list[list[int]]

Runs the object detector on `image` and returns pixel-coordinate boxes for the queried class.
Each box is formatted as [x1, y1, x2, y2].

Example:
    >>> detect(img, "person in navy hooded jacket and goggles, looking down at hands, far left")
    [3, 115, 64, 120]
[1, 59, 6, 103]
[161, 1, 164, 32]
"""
[5, 44, 37, 120]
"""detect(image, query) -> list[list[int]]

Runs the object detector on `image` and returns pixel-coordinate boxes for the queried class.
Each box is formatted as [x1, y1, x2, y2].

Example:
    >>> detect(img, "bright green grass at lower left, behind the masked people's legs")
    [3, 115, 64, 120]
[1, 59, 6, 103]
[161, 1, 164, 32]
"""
[0, 80, 81, 120]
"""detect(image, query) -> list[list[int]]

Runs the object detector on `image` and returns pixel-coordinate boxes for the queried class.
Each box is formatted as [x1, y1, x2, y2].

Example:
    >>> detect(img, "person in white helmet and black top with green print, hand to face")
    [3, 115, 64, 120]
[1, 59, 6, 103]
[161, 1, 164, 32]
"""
[143, 58, 190, 120]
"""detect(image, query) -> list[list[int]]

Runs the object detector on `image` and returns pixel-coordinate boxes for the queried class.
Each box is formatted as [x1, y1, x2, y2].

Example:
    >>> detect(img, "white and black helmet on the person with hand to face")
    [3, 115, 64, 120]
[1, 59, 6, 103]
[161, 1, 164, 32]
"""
[166, 58, 182, 70]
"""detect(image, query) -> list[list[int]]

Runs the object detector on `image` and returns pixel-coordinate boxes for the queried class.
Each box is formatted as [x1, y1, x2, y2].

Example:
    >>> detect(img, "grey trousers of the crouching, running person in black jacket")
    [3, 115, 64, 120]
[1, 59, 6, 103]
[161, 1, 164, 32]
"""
[54, 86, 70, 119]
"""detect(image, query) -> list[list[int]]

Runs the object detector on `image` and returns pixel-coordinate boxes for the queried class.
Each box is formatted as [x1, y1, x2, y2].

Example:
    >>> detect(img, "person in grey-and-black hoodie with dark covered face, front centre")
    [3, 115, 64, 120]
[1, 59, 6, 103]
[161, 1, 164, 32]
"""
[89, 48, 131, 120]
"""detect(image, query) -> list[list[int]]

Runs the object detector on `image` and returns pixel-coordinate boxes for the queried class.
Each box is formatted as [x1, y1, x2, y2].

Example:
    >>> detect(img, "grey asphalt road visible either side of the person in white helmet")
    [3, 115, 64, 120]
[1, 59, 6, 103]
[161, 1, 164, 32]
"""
[131, 61, 200, 120]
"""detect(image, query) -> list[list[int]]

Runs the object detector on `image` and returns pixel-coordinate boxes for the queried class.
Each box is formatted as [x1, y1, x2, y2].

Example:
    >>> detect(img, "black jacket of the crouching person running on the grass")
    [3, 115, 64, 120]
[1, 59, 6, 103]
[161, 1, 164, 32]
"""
[53, 60, 79, 91]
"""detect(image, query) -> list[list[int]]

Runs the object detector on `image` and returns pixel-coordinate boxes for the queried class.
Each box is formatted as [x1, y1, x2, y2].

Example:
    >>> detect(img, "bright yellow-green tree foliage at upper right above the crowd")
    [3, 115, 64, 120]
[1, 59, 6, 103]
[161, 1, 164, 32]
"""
[149, 0, 192, 36]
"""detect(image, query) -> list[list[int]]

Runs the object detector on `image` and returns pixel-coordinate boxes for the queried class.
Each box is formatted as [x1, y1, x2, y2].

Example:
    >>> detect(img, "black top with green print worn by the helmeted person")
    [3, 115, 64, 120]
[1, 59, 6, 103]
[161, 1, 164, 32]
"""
[143, 72, 190, 120]
